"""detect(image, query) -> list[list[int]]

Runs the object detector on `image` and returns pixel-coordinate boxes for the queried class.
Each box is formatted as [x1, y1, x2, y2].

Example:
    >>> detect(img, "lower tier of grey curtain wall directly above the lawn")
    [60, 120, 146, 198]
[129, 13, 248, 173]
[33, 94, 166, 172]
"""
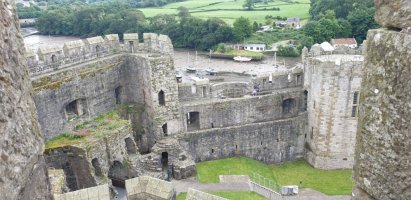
[179, 114, 307, 163]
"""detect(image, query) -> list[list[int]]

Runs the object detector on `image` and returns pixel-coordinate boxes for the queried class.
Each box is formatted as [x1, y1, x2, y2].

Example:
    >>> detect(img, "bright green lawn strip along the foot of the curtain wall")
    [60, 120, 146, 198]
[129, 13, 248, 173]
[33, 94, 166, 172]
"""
[196, 157, 353, 195]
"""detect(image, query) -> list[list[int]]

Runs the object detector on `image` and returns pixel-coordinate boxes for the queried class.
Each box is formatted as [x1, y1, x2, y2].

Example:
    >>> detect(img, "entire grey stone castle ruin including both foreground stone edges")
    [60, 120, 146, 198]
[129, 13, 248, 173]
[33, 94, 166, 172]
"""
[0, 0, 411, 199]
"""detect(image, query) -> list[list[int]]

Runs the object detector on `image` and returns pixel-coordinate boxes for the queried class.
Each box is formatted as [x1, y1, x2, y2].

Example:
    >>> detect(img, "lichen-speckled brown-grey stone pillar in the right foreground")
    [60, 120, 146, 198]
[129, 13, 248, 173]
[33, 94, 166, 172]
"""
[353, 0, 411, 200]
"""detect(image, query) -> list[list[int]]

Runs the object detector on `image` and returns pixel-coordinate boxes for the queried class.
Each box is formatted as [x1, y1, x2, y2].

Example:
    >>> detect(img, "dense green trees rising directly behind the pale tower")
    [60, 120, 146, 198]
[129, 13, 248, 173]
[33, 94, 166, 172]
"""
[304, 0, 378, 43]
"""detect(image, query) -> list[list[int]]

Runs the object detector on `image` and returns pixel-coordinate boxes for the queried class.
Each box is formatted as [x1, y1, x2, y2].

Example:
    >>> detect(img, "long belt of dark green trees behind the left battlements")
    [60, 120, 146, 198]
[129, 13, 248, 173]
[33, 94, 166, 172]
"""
[37, 3, 240, 50]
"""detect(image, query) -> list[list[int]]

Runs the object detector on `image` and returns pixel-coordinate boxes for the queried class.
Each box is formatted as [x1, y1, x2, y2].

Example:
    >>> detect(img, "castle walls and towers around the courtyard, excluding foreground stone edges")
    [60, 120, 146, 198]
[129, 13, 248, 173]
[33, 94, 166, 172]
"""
[26, 33, 363, 193]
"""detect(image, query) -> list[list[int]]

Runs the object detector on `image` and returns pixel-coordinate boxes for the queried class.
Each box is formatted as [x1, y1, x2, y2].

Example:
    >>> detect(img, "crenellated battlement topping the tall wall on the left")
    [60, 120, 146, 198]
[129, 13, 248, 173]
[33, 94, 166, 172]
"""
[26, 33, 173, 76]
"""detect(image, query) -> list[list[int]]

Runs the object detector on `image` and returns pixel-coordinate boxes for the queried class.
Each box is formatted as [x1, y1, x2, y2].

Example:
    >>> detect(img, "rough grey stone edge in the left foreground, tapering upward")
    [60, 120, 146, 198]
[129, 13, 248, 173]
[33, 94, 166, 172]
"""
[0, 0, 51, 199]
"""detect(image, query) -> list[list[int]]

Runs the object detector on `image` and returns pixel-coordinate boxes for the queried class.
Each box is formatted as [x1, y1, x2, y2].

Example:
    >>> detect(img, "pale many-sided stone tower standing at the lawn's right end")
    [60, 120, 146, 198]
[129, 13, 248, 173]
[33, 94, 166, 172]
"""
[304, 43, 363, 169]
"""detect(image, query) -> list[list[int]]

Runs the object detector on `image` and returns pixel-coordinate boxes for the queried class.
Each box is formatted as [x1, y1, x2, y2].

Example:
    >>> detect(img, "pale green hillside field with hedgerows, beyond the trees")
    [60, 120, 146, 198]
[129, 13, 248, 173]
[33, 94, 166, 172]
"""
[140, 0, 310, 24]
